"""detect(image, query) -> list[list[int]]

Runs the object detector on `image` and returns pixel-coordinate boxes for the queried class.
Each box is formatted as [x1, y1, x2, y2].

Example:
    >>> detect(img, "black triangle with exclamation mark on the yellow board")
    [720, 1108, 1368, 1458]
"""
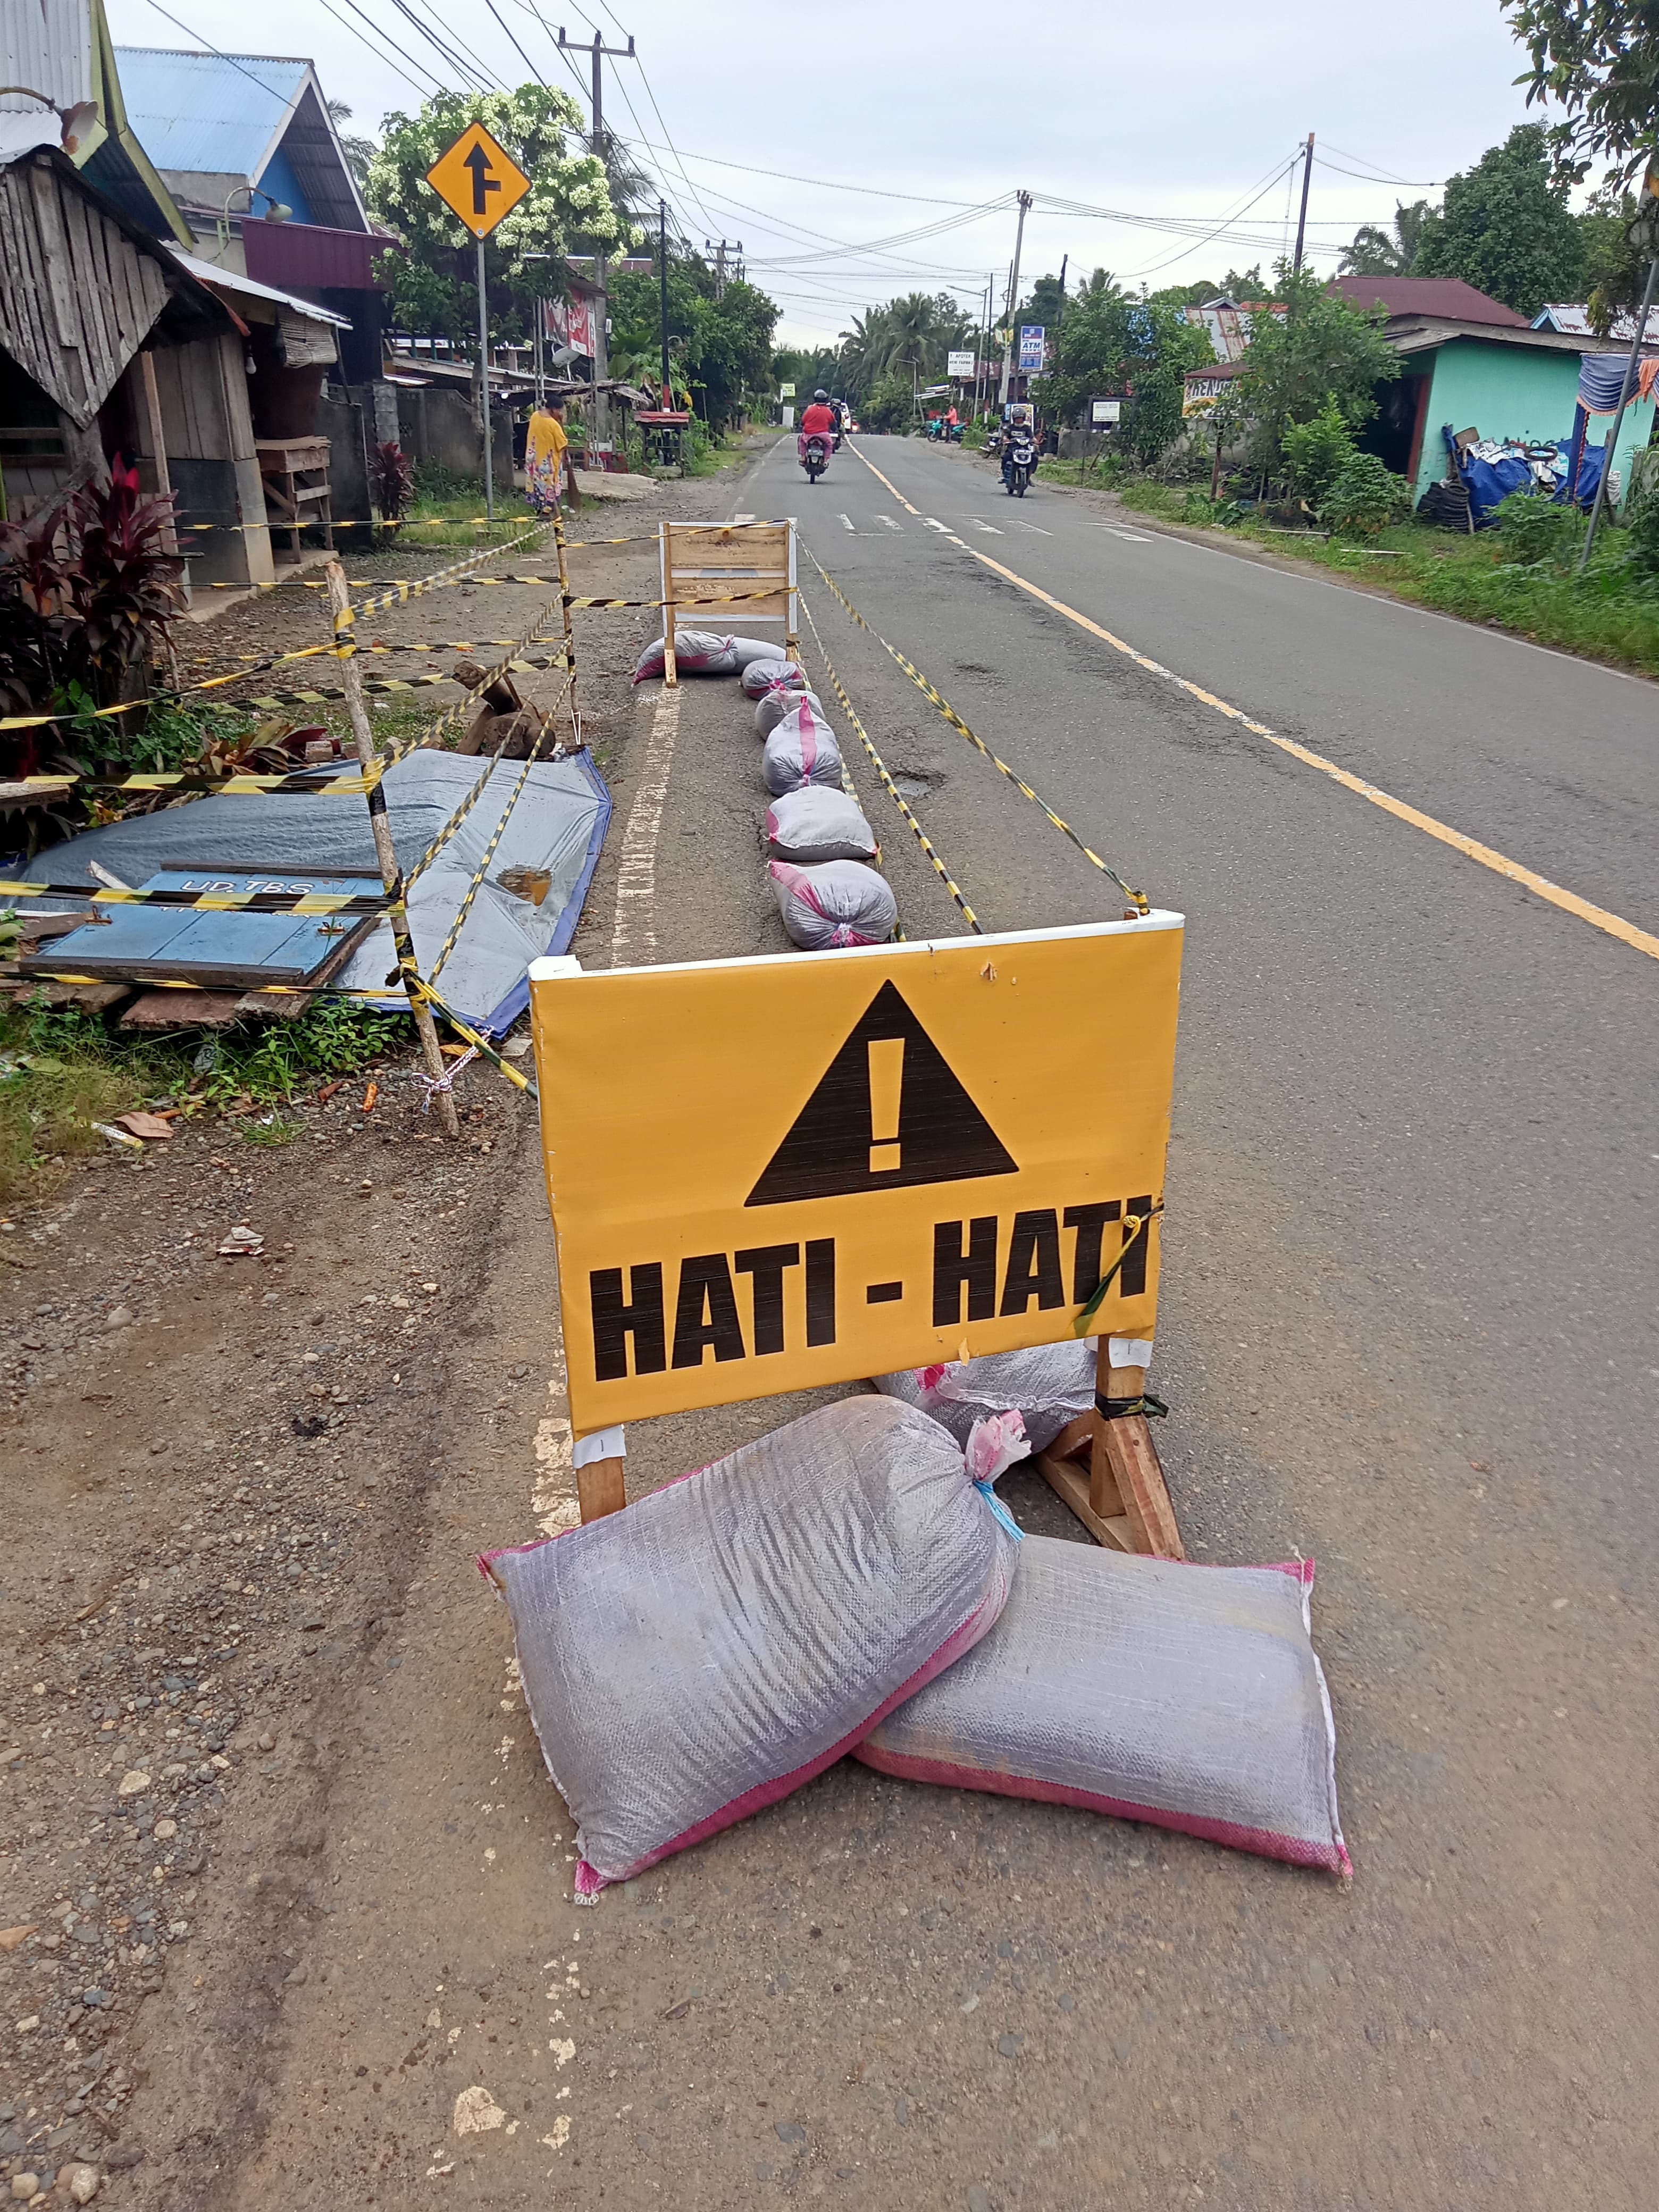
[743, 982, 1018, 1205]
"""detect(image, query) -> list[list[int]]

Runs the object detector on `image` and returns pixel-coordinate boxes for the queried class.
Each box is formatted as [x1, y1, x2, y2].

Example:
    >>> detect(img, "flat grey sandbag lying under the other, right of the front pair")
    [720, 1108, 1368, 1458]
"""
[858, 1535, 1352, 1876]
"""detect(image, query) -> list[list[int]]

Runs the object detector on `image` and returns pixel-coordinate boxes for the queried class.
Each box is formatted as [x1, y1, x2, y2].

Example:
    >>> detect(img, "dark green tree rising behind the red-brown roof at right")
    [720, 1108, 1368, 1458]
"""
[1415, 124, 1584, 319]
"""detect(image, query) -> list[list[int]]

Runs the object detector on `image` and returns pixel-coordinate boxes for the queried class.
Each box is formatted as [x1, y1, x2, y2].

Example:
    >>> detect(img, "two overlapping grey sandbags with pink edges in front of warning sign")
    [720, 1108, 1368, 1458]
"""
[480, 1396, 1350, 1900]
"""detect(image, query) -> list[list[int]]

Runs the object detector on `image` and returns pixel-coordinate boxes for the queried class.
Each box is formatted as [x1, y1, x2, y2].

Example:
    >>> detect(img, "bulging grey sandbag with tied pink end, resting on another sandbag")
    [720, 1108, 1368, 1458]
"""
[480, 1398, 1015, 1898]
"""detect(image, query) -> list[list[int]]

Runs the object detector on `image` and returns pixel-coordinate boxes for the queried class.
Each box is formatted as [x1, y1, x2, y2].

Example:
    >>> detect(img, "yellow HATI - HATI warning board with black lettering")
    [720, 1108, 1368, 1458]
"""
[531, 911, 1181, 1436]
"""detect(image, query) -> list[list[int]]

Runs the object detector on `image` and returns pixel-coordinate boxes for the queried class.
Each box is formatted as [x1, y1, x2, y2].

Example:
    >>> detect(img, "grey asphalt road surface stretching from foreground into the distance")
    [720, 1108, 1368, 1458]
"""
[188, 440, 1659, 2212]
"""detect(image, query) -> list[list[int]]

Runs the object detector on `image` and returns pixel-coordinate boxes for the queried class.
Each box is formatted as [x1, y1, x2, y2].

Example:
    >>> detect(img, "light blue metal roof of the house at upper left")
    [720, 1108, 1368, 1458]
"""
[115, 46, 312, 177]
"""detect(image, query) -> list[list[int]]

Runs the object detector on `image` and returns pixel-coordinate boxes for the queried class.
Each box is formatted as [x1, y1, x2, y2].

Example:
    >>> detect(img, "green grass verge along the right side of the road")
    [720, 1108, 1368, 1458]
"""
[1119, 480, 1659, 675]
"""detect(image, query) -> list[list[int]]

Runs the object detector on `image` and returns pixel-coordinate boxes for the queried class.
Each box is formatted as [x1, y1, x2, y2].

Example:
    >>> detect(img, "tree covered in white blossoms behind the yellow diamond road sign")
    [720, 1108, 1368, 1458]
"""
[365, 84, 631, 338]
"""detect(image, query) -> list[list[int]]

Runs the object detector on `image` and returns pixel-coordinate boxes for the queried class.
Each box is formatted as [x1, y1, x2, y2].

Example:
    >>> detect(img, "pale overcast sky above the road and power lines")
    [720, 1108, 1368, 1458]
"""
[106, 0, 1557, 345]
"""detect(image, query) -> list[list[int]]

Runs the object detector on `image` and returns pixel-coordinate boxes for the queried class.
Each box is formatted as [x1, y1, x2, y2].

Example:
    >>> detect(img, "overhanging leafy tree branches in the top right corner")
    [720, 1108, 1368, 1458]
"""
[1502, 0, 1659, 192]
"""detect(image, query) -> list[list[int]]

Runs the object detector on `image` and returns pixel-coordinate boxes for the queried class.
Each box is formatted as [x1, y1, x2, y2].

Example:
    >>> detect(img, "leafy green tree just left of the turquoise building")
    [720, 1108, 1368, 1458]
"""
[1234, 261, 1400, 484]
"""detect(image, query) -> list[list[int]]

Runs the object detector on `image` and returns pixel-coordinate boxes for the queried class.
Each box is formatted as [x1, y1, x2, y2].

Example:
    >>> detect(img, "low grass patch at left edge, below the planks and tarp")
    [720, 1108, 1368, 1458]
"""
[0, 993, 405, 1203]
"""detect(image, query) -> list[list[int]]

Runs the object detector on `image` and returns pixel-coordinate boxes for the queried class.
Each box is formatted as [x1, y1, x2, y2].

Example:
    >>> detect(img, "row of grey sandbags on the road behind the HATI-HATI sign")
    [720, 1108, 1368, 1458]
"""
[633, 631, 898, 951]
